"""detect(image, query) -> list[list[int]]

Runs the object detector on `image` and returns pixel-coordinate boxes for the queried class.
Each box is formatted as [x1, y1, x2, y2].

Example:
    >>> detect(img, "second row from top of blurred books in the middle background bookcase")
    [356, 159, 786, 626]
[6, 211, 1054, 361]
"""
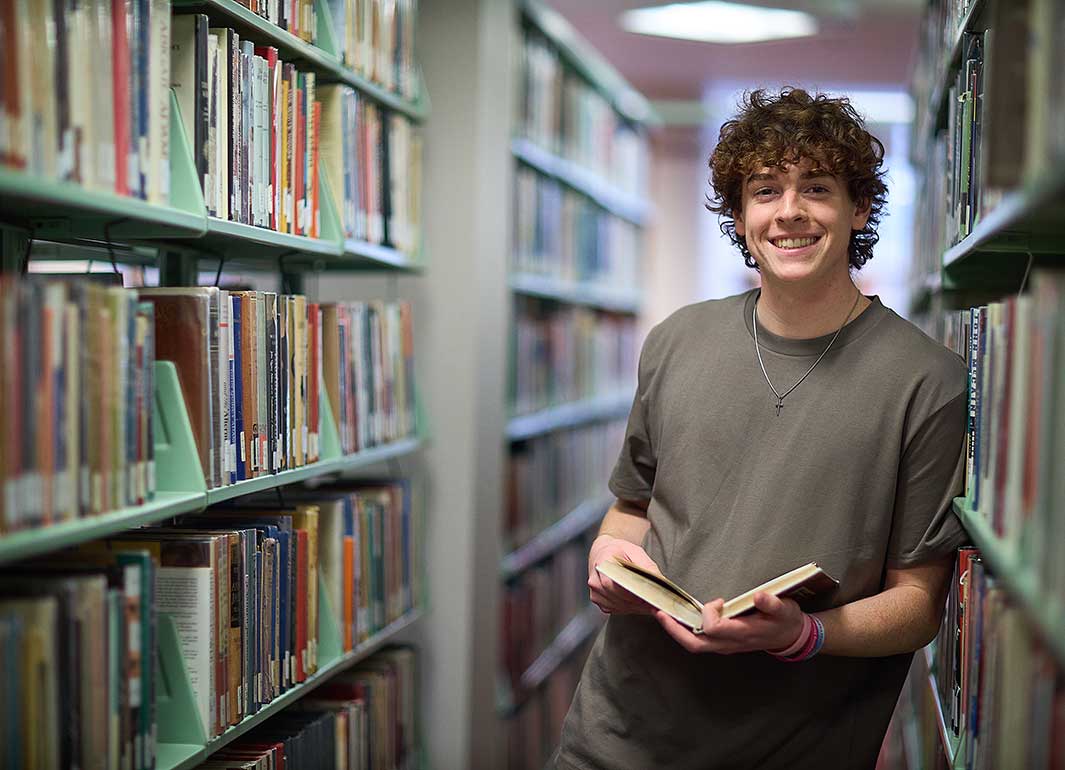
[514, 166, 640, 290]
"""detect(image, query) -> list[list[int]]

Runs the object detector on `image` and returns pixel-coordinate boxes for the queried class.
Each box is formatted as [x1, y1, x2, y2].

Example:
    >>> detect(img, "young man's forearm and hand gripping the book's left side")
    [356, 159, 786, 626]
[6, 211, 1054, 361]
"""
[588, 499, 661, 615]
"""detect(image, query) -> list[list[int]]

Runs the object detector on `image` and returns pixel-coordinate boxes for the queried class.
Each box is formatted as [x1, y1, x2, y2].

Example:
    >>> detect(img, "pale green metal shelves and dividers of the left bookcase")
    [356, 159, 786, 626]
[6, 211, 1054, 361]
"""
[0, 0, 429, 770]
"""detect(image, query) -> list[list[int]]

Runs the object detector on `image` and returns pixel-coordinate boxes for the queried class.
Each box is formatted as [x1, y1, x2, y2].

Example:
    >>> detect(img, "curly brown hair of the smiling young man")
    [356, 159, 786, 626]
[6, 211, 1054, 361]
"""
[706, 87, 887, 271]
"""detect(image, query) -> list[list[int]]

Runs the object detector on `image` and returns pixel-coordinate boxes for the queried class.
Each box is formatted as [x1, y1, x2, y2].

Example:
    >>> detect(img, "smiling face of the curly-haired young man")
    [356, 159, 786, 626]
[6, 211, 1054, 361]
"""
[736, 159, 869, 283]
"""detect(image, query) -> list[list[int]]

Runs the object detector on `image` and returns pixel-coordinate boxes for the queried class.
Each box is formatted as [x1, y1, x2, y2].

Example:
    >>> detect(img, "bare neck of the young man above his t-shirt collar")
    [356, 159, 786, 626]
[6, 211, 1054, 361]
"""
[757, 274, 871, 340]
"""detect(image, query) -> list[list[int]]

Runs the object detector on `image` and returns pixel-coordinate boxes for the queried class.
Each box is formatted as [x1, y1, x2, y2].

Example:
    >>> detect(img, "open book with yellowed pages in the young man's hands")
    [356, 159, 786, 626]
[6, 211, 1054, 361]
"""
[595, 559, 839, 634]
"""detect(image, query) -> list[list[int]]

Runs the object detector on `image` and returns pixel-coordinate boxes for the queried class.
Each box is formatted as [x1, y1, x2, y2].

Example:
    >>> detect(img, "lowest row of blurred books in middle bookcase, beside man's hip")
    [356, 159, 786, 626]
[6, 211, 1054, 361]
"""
[506, 640, 592, 770]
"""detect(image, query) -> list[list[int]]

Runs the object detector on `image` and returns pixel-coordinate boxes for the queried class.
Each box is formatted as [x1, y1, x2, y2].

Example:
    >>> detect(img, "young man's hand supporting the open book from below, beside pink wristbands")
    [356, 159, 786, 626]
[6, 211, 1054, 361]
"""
[655, 591, 803, 655]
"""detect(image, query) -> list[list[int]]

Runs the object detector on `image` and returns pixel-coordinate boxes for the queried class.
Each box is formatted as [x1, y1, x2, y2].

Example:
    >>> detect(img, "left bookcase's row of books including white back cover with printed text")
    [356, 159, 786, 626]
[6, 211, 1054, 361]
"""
[0, 481, 419, 769]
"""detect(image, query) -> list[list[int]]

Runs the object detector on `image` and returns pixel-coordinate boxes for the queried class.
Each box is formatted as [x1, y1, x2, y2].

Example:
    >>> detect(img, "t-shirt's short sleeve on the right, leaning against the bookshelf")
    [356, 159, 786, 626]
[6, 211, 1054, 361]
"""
[887, 392, 968, 568]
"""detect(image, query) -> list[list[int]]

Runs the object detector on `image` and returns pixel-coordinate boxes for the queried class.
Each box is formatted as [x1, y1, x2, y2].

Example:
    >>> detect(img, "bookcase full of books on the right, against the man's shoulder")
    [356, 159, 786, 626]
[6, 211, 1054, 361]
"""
[889, 0, 1065, 770]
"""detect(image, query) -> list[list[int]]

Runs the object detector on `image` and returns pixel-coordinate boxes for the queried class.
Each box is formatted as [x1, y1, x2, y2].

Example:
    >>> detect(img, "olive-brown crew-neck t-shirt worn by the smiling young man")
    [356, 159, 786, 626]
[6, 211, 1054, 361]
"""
[556, 290, 966, 770]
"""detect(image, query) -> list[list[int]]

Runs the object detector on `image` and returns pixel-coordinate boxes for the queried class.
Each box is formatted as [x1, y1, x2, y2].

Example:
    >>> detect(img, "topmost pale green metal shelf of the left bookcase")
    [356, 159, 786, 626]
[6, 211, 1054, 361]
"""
[173, 0, 426, 120]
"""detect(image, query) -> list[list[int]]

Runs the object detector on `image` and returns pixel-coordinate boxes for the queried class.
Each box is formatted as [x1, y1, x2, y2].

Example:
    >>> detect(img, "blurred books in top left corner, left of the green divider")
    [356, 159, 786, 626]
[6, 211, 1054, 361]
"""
[0, 0, 170, 203]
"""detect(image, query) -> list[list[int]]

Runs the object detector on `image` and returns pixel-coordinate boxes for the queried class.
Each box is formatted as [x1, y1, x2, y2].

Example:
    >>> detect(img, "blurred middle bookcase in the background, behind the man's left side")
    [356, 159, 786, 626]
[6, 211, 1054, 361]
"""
[492, 1, 655, 768]
